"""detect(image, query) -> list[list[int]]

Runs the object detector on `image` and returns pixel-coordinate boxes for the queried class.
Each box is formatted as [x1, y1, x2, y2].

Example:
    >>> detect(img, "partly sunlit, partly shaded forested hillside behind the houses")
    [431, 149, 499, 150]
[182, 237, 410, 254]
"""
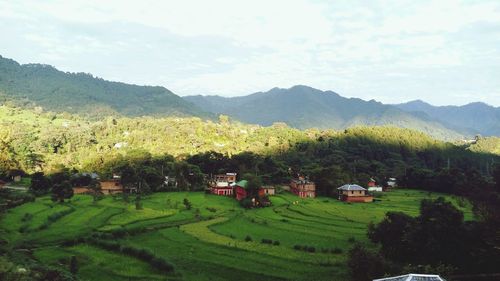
[0, 106, 500, 194]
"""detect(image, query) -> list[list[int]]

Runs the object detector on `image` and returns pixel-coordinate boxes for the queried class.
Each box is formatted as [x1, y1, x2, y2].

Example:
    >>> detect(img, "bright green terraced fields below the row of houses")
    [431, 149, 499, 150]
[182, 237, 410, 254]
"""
[0, 189, 472, 280]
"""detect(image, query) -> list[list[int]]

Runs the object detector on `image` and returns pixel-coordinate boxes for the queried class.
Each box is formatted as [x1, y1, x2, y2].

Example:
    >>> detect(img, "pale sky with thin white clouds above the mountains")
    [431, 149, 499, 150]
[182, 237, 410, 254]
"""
[0, 0, 500, 106]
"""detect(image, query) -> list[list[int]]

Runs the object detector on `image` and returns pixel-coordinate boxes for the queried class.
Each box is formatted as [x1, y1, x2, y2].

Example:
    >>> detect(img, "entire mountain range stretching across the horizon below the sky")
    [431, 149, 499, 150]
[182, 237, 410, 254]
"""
[0, 56, 500, 140]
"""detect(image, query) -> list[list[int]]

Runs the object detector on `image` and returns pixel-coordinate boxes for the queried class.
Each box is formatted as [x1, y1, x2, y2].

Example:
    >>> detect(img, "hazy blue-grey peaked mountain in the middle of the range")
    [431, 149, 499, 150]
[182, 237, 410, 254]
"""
[184, 85, 467, 139]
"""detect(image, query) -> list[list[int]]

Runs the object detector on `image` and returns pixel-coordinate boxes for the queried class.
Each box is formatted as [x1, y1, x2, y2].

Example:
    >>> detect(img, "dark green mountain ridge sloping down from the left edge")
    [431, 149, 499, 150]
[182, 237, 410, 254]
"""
[0, 56, 211, 117]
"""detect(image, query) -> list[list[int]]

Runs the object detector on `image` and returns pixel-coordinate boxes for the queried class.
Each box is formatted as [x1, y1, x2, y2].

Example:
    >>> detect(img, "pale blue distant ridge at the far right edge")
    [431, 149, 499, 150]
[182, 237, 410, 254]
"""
[395, 100, 500, 136]
